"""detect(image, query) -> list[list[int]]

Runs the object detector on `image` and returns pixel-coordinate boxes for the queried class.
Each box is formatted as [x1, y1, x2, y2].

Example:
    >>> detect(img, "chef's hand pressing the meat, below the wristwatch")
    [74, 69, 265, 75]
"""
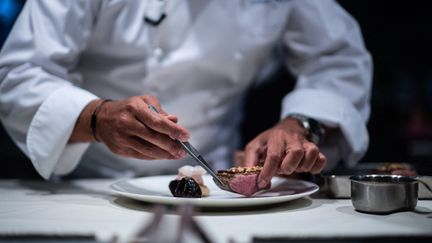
[244, 118, 326, 189]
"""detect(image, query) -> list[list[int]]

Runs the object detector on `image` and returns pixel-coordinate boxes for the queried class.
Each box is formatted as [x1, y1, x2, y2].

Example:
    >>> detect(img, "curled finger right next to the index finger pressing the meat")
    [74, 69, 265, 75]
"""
[280, 141, 304, 175]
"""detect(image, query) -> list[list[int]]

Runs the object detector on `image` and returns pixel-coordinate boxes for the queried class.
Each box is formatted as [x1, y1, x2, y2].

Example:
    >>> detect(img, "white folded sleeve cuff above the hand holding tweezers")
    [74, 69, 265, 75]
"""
[27, 86, 98, 180]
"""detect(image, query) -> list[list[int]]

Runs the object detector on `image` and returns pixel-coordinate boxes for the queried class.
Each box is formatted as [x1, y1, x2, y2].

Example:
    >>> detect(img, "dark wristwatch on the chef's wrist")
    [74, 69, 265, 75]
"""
[287, 114, 325, 145]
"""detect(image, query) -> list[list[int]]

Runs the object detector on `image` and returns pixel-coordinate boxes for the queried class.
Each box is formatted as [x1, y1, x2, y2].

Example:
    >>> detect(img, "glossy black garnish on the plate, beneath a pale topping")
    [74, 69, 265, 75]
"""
[169, 177, 202, 198]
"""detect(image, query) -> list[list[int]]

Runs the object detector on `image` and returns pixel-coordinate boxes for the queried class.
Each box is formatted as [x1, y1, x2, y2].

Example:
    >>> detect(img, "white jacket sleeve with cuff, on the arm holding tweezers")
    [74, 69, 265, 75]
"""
[0, 0, 98, 179]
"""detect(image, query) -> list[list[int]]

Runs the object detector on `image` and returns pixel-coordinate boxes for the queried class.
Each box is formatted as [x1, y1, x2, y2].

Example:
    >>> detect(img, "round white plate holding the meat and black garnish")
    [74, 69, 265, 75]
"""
[111, 175, 319, 207]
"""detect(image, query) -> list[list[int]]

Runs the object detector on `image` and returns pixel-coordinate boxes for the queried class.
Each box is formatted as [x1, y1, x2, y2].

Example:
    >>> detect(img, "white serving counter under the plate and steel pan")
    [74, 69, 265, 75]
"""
[0, 180, 432, 243]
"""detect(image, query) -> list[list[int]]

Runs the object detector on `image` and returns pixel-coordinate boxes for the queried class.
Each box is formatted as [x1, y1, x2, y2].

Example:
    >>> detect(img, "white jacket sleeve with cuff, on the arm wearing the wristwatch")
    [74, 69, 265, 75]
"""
[281, 0, 372, 169]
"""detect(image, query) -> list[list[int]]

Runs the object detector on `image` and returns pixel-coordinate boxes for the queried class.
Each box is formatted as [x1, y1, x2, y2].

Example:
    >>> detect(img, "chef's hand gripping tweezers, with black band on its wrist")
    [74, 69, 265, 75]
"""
[69, 96, 189, 160]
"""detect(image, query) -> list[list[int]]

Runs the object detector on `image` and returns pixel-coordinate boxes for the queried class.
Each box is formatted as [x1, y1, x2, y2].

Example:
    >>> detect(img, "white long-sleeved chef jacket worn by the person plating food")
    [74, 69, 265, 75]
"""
[0, 0, 372, 179]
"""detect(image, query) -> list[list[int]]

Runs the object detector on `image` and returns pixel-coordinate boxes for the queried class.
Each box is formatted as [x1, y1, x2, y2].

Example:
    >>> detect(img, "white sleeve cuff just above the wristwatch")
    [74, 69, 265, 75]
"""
[281, 89, 369, 166]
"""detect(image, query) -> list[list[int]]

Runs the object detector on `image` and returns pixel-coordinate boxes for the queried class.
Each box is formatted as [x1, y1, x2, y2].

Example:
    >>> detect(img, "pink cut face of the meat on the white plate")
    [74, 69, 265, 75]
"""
[229, 174, 259, 197]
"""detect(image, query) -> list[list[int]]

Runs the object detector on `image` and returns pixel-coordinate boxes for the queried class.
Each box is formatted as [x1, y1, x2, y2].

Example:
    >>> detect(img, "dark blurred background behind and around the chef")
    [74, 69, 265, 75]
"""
[0, 0, 432, 178]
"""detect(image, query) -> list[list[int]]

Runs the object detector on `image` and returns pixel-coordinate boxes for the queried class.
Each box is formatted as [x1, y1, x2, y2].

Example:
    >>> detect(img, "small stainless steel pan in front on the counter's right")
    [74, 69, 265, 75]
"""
[350, 175, 418, 214]
